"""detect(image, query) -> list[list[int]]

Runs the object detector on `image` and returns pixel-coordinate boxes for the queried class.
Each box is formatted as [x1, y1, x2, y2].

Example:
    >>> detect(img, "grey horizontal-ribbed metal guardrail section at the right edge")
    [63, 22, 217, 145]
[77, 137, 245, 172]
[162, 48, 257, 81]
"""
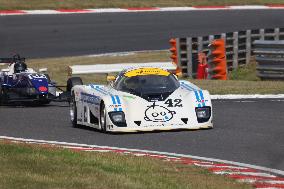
[253, 40, 284, 79]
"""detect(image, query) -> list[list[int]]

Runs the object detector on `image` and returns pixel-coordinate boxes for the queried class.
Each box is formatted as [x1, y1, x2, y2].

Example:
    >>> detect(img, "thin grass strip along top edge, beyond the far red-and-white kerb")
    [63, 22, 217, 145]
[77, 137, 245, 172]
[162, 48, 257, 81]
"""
[0, 0, 283, 10]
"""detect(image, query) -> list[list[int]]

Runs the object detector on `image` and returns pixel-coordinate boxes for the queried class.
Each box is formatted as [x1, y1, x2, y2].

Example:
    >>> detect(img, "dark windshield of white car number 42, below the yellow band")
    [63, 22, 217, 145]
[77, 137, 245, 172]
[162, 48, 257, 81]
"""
[115, 74, 179, 96]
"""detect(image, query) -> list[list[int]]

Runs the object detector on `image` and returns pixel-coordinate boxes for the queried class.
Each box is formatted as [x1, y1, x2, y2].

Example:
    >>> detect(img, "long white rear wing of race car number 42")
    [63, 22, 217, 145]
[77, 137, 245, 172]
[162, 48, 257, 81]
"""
[69, 62, 177, 75]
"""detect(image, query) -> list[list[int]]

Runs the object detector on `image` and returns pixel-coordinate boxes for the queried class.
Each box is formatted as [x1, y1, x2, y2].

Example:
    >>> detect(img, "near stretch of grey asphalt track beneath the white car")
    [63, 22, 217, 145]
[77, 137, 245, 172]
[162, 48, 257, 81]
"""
[0, 100, 284, 170]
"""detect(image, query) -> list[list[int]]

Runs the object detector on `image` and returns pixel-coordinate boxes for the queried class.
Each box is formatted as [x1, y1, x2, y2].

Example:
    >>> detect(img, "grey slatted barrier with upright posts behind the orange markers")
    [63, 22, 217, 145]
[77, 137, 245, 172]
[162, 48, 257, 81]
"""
[176, 28, 284, 77]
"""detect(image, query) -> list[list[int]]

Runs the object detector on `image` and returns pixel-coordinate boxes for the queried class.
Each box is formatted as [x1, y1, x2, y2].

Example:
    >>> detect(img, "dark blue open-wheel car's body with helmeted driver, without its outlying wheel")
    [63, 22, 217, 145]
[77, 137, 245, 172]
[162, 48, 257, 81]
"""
[0, 55, 56, 104]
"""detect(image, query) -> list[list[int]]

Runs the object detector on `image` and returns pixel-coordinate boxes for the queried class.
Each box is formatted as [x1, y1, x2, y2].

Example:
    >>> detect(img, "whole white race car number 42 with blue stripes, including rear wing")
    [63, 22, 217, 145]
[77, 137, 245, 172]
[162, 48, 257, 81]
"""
[67, 64, 213, 132]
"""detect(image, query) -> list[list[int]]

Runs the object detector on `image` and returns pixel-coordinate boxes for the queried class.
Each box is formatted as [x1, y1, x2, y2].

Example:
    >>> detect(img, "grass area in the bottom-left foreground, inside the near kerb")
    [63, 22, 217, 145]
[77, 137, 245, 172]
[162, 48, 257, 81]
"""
[0, 141, 252, 189]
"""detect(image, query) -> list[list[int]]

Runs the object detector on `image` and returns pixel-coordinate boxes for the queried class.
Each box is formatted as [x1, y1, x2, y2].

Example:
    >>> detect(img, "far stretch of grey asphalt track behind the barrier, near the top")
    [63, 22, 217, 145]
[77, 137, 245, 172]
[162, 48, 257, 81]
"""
[0, 10, 284, 58]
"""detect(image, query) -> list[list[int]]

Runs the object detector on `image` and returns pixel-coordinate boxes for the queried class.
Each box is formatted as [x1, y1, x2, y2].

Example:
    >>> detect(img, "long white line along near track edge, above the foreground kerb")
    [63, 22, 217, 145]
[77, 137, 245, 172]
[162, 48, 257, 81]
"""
[0, 136, 284, 176]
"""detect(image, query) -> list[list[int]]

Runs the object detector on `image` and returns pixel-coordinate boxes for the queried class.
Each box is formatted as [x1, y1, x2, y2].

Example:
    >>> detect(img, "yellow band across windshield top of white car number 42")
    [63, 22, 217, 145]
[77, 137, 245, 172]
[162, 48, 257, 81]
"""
[124, 68, 170, 77]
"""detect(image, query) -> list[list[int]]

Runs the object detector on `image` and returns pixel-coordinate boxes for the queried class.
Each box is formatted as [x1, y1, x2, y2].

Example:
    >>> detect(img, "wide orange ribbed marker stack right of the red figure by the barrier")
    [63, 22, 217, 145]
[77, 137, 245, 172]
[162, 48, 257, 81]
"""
[208, 39, 227, 80]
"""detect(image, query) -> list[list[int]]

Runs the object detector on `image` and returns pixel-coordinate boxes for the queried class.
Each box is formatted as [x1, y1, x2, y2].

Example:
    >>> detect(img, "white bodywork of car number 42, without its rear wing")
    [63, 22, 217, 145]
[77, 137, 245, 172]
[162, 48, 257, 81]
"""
[67, 62, 213, 132]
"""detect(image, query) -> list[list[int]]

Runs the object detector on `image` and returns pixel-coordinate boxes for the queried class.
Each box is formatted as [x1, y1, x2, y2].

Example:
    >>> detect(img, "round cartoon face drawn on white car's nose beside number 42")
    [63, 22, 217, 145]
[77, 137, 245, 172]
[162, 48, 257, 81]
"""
[144, 102, 176, 122]
